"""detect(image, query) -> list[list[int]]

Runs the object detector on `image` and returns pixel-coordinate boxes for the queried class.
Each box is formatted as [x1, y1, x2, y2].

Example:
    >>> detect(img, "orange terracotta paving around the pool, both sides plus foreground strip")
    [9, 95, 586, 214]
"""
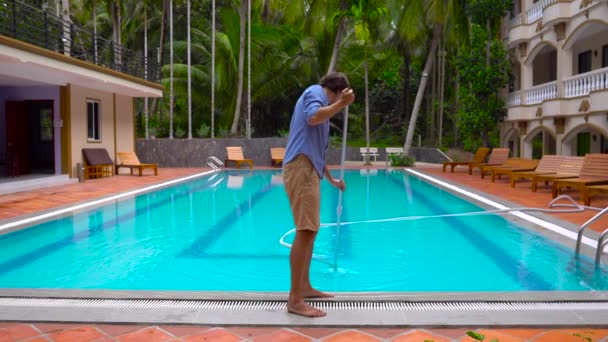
[0, 167, 608, 342]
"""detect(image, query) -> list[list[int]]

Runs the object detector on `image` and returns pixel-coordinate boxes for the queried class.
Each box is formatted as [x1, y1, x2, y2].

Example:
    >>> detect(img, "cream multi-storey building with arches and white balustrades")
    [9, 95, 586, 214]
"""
[501, 0, 608, 158]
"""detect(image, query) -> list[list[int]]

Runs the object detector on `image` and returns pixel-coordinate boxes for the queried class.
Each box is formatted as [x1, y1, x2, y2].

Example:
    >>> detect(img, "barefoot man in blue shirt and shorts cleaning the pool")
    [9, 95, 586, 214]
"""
[283, 72, 355, 317]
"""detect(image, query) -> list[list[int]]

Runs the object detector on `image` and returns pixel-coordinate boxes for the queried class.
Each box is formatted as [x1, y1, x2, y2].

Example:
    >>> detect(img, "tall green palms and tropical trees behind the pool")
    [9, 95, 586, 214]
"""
[51, 0, 509, 151]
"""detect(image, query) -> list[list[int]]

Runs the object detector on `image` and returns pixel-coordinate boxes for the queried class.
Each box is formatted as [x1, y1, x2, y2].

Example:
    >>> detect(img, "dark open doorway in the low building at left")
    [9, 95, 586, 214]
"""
[6, 100, 55, 176]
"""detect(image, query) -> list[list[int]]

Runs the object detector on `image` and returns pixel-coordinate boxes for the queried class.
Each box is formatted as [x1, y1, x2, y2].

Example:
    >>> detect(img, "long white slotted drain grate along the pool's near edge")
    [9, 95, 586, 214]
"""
[0, 297, 608, 312]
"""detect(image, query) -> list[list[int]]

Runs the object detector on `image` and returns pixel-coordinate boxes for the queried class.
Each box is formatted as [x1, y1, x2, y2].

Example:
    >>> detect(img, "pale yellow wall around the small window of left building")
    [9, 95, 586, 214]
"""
[69, 85, 135, 177]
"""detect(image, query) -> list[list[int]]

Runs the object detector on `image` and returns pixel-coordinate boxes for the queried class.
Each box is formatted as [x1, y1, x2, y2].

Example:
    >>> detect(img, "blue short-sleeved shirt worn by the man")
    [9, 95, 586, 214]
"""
[283, 84, 329, 178]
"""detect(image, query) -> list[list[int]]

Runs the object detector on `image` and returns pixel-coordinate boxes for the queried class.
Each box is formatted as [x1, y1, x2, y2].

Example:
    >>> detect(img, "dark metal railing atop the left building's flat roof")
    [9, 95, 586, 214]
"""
[0, 0, 160, 81]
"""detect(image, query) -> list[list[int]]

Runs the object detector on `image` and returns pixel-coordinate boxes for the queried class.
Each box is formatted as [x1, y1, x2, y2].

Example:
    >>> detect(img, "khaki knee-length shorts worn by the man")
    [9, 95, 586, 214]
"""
[283, 154, 321, 232]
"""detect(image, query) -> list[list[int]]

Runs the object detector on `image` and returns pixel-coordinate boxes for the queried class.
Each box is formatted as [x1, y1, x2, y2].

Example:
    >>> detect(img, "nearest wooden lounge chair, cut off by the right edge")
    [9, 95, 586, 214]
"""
[552, 153, 608, 203]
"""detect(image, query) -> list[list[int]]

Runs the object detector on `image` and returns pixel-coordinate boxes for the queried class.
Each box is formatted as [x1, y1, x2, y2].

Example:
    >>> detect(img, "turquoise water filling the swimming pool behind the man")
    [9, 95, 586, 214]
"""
[0, 170, 608, 292]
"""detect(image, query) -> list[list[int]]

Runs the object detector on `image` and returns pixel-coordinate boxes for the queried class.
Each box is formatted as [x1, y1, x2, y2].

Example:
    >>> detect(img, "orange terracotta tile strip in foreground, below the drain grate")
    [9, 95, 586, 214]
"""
[0, 322, 608, 342]
